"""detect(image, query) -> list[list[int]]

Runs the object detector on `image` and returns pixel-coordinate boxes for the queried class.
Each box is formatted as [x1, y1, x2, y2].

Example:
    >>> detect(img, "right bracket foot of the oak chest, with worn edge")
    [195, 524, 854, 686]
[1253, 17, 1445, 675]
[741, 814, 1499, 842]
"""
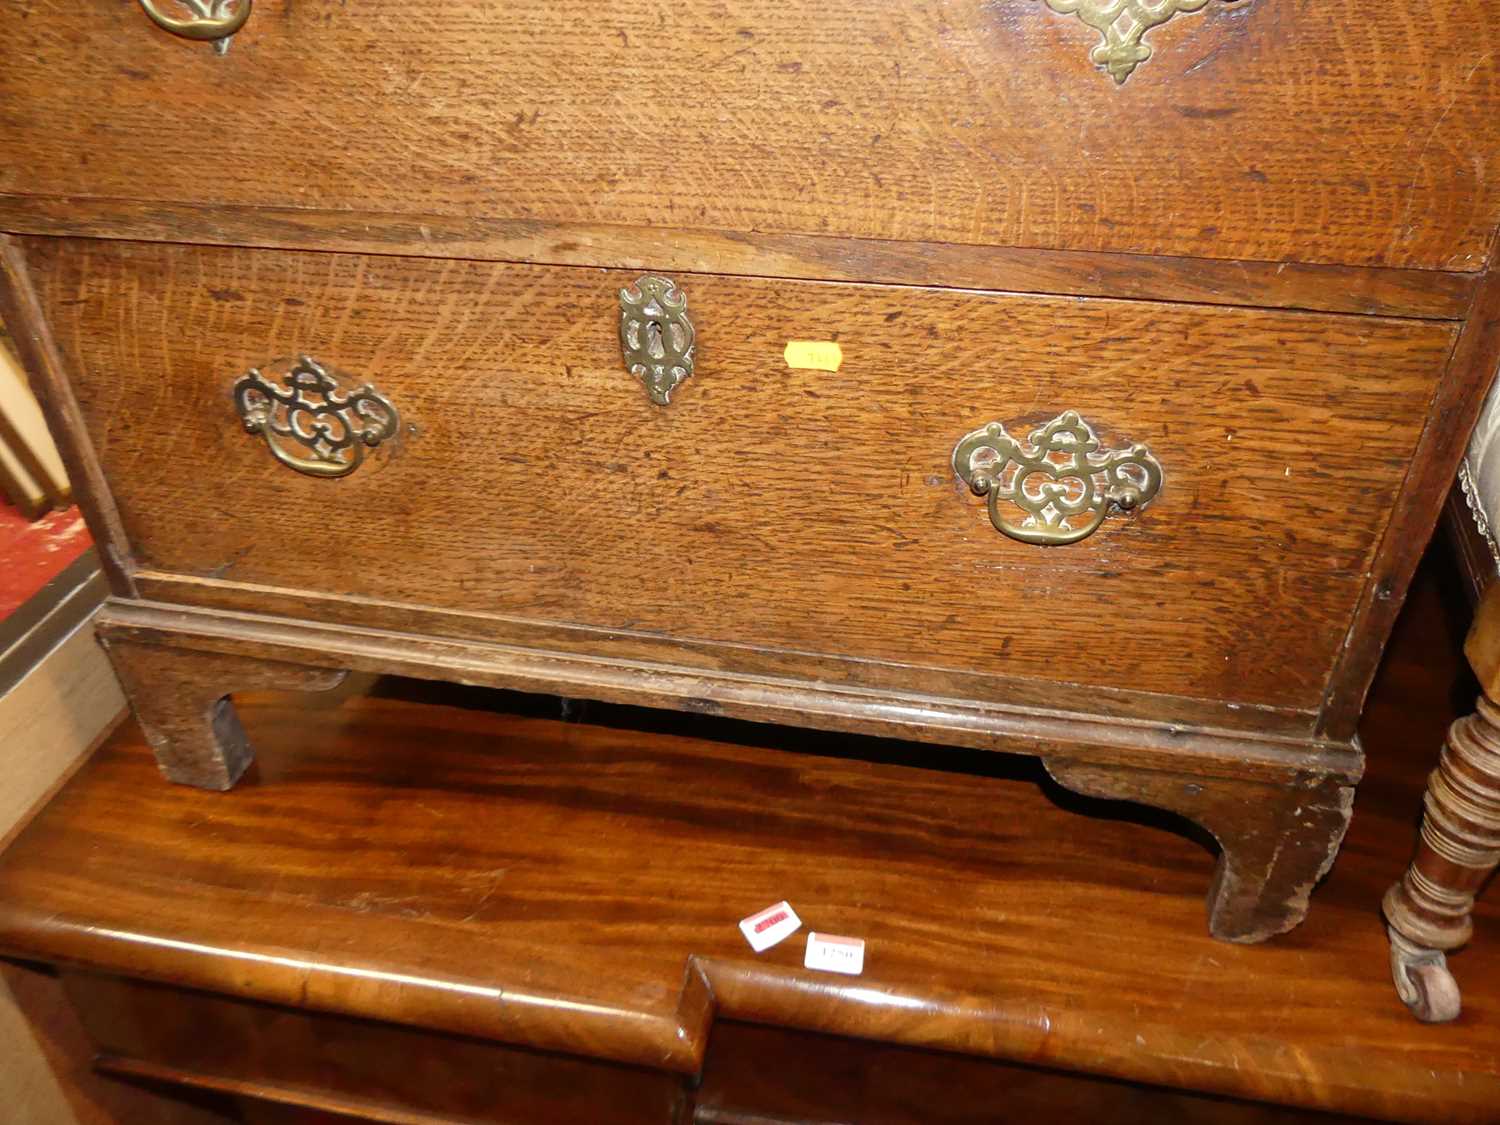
[1046, 758, 1355, 942]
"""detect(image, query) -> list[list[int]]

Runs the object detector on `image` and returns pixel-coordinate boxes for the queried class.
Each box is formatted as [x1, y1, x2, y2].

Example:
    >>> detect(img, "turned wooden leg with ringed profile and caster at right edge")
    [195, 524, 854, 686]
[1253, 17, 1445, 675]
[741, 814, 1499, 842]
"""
[1383, 696, 1500, 1023]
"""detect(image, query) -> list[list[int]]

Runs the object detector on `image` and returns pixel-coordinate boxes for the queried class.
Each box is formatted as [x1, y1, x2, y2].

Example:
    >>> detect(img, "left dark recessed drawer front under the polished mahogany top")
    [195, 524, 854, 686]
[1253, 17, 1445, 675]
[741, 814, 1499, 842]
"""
[63, 972, 687, 1125]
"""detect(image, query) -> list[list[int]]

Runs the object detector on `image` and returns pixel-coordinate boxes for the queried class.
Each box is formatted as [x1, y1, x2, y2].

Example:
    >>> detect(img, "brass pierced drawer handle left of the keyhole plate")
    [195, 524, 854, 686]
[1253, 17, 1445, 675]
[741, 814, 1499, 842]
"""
[233, 356, 401, 477]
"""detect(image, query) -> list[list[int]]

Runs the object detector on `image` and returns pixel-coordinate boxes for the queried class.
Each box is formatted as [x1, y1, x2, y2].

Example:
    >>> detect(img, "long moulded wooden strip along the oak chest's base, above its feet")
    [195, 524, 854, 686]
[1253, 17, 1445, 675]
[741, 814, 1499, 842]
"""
[98, 599, 1364, 785]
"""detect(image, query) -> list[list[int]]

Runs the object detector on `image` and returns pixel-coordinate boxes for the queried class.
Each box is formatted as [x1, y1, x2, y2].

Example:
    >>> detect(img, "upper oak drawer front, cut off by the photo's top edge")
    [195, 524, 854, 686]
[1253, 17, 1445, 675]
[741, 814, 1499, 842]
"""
[0, 0, 1500, 270]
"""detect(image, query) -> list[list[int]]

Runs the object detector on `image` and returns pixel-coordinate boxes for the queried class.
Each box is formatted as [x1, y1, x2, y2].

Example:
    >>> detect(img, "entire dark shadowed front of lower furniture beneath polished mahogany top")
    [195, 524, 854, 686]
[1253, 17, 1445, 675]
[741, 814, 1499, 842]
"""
[65, 974, 1365, 1125]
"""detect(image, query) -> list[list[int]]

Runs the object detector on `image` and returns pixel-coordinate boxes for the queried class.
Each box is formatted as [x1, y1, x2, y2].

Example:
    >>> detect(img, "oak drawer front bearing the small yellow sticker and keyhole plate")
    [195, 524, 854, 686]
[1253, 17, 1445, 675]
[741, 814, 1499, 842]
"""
[27, 240, 1454, 708]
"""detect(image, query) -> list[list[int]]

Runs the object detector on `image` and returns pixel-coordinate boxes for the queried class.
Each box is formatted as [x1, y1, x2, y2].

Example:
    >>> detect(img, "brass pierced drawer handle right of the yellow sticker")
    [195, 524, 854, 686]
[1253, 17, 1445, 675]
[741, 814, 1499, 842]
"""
[953, 410, 1161, 546]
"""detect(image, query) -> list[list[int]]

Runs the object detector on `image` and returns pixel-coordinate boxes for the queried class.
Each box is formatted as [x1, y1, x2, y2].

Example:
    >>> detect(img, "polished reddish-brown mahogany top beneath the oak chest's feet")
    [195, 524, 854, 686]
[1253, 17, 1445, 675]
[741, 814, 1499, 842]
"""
[0, 558, 1500, 1125]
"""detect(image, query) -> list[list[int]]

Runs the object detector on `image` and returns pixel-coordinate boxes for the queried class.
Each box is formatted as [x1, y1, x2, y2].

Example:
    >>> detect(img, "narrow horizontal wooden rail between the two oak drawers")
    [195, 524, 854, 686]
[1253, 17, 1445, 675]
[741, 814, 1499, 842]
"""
[0, 192, 1479, 320]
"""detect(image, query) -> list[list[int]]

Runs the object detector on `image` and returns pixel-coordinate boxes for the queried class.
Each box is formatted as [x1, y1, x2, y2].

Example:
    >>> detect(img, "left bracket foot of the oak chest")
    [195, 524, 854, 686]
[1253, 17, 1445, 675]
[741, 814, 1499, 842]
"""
[99, 633, 347, 789]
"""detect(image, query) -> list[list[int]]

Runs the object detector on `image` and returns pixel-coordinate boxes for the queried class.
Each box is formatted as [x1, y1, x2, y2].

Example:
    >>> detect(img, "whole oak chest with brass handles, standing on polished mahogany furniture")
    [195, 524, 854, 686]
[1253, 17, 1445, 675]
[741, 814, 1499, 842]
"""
[0, 0, 1500, 941]
